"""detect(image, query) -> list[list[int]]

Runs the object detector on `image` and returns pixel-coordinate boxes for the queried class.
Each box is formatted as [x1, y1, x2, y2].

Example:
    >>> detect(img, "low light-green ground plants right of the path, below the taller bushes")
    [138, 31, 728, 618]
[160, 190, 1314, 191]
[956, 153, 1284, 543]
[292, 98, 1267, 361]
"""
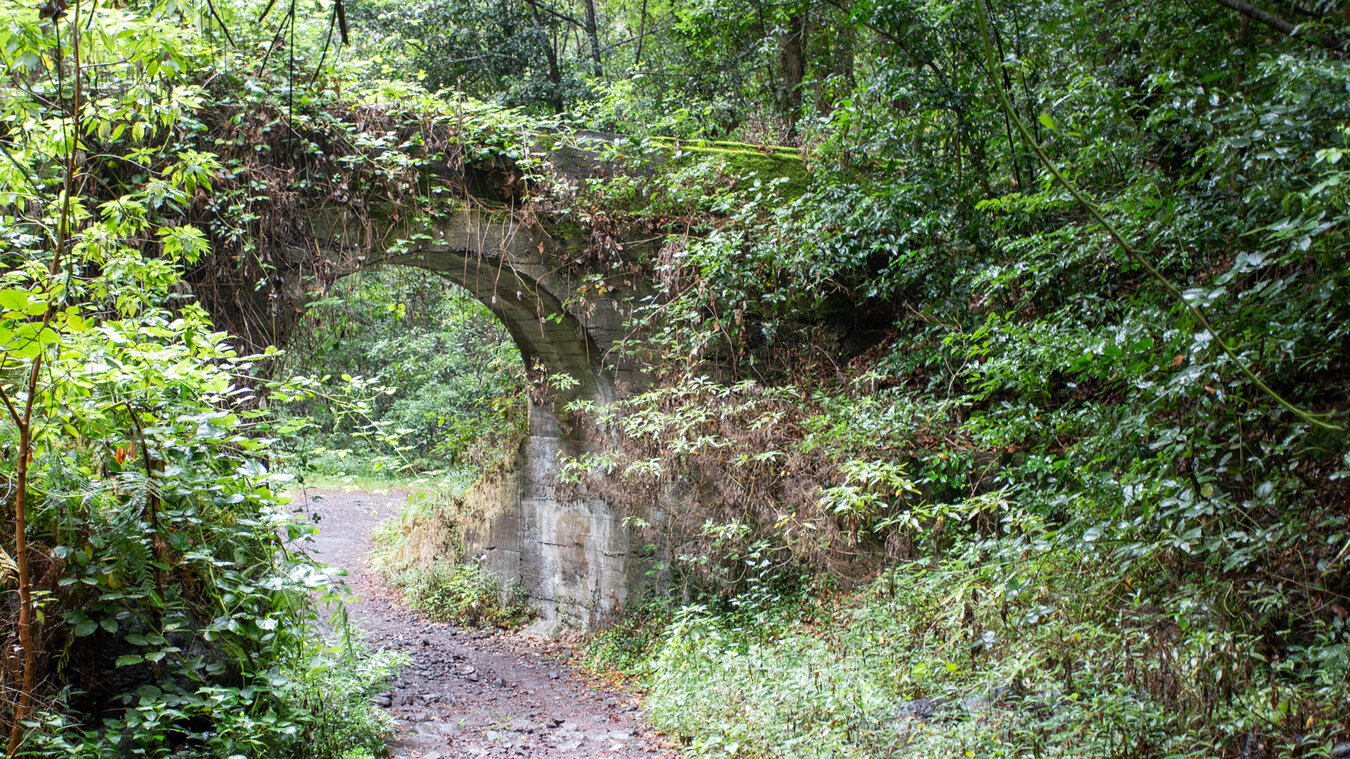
[582, 537, 1346, 756]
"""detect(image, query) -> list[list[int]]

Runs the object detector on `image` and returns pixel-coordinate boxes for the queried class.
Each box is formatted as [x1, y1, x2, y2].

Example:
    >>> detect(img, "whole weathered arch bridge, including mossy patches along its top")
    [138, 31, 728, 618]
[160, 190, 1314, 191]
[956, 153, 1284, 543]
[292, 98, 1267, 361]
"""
[194, 135, 802, 633]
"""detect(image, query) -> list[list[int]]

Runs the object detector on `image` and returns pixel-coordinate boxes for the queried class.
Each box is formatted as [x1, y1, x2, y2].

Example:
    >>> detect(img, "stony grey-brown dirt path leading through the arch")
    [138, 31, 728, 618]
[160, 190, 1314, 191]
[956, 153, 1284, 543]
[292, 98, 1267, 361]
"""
[292, 490, 678, 759]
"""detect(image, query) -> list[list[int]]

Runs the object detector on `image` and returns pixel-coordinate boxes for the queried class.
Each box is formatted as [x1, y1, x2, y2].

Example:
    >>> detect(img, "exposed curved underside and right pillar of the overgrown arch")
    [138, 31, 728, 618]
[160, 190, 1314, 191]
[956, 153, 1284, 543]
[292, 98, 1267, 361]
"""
[315, 202, 648, 633]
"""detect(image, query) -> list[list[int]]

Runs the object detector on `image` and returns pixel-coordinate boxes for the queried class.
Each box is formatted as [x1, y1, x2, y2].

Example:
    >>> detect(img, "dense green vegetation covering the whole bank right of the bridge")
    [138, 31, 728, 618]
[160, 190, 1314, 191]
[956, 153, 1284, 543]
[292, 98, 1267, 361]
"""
[553, 3, 1350, 756]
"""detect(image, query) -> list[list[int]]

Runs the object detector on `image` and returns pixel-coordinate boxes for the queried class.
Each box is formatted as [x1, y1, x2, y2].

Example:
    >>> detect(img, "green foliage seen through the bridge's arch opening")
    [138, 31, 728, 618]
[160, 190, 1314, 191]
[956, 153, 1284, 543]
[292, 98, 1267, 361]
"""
[282, 267, 528, 481]
